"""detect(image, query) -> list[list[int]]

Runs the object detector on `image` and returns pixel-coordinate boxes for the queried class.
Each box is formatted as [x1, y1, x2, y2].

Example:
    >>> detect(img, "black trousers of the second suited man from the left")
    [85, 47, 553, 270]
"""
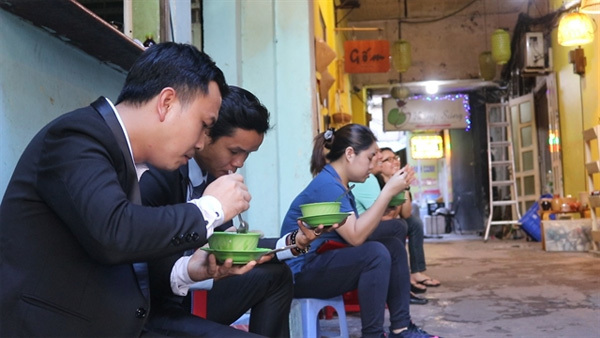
[147, 262, 294, 337]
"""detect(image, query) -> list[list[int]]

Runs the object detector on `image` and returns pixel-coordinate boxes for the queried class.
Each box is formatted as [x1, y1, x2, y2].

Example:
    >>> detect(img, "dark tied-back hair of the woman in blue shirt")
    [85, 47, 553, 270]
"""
[310, 124, 377, 176]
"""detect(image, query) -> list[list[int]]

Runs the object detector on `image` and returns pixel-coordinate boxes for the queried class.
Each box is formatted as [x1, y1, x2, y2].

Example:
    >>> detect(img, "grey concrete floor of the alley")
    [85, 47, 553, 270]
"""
[320, 234, 600, 338]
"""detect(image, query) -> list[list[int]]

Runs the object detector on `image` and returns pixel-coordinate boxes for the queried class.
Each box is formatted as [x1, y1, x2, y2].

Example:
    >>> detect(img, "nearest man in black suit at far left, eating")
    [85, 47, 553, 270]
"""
[0, 43, 268, 337]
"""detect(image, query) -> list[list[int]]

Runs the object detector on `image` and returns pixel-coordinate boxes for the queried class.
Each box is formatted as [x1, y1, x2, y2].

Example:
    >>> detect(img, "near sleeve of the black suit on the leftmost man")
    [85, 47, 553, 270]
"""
[36, 111, 206, 264]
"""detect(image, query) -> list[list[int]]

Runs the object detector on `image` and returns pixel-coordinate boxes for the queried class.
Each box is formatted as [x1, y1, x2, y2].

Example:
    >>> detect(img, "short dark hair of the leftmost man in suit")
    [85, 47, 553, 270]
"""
[116, 42, 229, 105]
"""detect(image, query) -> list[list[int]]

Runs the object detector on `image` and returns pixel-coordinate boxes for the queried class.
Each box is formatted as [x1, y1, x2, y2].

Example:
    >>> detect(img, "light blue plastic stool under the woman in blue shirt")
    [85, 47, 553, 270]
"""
[296, 295, 348, 338]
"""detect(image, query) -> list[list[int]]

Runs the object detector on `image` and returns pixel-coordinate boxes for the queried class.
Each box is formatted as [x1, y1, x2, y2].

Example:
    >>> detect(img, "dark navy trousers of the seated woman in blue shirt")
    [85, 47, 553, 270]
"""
[294, 219, 411, 337]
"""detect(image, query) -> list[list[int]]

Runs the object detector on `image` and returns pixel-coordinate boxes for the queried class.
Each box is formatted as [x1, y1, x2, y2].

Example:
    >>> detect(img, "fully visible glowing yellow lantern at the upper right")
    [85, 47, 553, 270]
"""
[558, 12, 594, 46]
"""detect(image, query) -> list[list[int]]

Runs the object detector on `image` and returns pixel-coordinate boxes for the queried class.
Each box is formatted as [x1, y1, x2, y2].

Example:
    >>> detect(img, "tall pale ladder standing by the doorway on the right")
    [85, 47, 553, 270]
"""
[483, 103, 521, 242]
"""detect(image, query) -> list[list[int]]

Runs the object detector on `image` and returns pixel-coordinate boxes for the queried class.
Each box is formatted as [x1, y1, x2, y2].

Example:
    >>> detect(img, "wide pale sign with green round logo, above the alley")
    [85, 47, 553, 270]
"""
[383, 94, 469, 131]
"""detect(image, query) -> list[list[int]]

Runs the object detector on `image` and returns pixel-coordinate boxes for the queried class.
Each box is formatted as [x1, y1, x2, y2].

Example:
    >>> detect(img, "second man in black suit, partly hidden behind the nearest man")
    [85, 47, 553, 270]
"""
[140, 86, 314, 337]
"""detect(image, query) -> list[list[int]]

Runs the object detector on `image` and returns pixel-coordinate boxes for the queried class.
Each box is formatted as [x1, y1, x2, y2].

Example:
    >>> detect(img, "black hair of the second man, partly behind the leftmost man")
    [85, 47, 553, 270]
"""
[209, 86, 270, 142]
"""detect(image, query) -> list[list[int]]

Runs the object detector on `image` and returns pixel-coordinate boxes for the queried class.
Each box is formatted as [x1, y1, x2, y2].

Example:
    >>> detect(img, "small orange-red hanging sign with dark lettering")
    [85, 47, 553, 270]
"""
[344, 40, 390, 73]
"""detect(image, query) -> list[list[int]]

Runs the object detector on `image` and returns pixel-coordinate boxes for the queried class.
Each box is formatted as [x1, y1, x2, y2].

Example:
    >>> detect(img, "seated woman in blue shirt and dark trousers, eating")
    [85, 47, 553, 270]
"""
[281, 124, 432, 337]
